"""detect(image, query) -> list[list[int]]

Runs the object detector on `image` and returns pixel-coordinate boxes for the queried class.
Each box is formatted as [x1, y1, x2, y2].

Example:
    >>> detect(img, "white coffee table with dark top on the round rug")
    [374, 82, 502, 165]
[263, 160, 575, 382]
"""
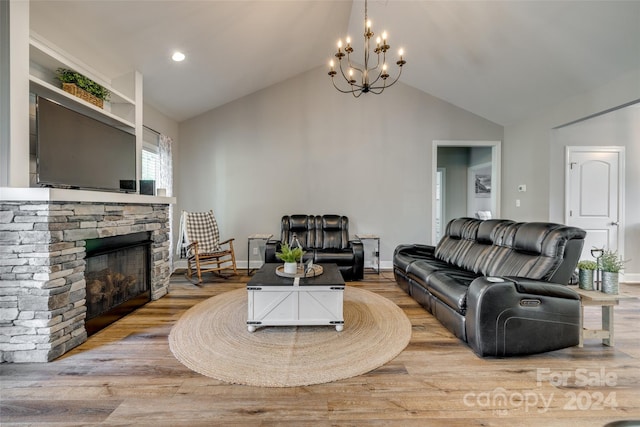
[247, 264, 345, 332]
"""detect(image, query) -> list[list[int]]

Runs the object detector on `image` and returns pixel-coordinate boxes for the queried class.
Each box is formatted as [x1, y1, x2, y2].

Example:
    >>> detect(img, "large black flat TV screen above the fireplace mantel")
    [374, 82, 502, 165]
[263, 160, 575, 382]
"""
[36, 97, 136, 191]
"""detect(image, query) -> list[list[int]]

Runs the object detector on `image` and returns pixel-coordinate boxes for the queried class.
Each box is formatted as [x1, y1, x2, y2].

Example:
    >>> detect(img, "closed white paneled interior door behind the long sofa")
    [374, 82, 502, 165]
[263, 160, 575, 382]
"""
[566, 147, 624, 259]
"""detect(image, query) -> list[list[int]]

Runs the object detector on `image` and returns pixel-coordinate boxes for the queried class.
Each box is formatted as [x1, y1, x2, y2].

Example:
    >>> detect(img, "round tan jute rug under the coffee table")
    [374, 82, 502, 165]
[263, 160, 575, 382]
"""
[169, 286, 411, 387]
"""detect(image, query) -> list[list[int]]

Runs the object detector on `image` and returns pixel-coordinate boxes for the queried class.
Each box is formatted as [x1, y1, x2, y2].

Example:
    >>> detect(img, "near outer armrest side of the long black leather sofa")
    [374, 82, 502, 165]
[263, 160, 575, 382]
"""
[465, 277, 581, 357]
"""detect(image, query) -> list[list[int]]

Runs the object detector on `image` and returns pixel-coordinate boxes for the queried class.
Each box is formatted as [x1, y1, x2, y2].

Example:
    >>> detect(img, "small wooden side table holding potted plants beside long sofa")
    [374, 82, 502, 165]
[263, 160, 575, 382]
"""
[575, 288, 633, 347]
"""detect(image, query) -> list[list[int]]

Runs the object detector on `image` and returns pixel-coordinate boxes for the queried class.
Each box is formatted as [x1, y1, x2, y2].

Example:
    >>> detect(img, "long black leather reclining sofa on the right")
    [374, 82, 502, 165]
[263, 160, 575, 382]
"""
[393, 218, 586, 357]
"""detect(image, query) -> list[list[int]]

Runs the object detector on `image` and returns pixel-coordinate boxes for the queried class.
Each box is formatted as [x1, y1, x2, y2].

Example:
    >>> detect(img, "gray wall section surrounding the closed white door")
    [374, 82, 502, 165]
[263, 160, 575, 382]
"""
[502, 70, 640, 282]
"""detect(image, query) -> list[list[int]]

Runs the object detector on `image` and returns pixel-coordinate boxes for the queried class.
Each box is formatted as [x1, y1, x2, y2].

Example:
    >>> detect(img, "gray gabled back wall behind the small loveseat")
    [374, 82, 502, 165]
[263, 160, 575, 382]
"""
[174, 67, 503, 267]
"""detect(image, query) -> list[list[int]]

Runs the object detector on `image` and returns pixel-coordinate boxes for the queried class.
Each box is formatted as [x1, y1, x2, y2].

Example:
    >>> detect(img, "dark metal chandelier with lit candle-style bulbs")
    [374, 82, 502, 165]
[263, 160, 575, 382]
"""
[329, 0, 407, 98]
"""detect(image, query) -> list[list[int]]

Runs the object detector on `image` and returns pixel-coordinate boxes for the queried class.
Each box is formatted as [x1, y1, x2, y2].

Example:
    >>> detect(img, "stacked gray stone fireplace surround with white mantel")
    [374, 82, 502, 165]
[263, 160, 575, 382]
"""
[0, 189, 175, 363]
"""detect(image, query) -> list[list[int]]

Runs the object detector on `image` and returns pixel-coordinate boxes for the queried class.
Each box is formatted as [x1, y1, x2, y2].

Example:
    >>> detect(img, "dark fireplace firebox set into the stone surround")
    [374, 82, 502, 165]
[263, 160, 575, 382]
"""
[85, 232, 152, 335]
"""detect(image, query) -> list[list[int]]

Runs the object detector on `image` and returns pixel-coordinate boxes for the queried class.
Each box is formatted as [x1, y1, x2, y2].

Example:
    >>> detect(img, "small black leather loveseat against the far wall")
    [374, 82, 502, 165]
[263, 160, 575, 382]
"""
[265, 215, 364, 280]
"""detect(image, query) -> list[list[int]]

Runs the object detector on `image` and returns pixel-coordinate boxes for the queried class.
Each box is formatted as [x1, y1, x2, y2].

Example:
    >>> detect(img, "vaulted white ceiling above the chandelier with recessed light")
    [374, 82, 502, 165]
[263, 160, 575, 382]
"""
[30, 0, 640, 125]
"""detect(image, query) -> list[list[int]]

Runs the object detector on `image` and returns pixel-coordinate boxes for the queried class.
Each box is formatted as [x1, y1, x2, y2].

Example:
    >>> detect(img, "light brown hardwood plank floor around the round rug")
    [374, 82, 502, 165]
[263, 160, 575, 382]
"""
[0, 271, 640, 426]
